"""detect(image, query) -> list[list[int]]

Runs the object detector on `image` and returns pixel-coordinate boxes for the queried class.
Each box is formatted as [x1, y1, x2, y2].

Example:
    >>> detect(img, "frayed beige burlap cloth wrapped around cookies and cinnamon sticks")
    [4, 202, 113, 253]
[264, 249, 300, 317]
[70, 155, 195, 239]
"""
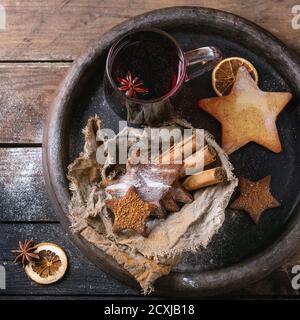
[68, 117, 238, 294]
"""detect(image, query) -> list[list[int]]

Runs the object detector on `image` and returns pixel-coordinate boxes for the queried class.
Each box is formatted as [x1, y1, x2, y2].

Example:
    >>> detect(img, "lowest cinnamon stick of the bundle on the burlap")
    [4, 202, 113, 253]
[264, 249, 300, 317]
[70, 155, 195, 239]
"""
[182, 167, 227, 190]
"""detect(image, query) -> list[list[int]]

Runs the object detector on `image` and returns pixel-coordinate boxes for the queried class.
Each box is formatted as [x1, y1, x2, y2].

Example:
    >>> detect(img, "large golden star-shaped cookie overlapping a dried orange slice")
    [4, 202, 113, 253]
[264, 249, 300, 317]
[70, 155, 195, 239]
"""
[198, 67, 292, 154]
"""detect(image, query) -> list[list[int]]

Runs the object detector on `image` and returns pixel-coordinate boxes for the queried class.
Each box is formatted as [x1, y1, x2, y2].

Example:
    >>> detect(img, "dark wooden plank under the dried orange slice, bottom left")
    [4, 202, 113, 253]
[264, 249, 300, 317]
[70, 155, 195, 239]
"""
[0, 223, 139, 297]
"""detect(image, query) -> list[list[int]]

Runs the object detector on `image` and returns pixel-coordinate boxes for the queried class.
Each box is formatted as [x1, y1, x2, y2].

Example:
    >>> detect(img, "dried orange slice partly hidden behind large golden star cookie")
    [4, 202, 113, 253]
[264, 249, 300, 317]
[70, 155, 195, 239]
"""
[212, 57, 258, 96]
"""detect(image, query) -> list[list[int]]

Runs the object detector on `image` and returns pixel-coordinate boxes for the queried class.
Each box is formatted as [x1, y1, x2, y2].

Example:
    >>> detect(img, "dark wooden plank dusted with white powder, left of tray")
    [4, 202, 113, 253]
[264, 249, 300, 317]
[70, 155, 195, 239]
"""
[0, 148, 57, 221]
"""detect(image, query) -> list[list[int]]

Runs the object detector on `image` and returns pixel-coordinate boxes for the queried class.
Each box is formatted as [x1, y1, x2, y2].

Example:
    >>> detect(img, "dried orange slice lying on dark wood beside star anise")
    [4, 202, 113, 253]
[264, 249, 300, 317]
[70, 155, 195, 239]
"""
[25, 242, 68, 284]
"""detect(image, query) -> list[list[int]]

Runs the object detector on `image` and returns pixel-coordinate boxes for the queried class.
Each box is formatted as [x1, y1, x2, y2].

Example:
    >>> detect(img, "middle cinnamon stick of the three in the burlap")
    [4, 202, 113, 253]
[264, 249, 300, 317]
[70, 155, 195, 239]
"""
[180, 145, 217, 177]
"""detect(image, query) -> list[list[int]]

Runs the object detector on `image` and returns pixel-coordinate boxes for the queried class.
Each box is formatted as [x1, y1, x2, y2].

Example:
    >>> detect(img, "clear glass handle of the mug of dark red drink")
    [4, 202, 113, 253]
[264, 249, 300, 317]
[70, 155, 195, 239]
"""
[184, 47, 222, 82]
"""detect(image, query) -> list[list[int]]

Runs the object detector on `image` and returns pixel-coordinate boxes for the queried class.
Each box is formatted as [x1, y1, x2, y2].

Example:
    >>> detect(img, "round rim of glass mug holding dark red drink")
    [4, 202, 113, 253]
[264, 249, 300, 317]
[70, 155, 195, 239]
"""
[105, 28, 187, 104]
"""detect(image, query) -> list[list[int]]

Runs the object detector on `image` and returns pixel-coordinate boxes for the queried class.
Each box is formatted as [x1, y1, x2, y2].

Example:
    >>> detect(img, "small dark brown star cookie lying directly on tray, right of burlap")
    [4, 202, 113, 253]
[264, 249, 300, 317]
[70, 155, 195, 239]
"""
[229, 176, 280, 223]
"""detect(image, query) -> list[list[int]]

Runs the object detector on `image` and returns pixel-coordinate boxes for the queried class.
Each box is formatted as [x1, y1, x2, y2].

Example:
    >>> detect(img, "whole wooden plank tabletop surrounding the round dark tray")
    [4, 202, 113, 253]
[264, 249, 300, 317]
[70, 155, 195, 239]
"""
[0, 0, 300, 299]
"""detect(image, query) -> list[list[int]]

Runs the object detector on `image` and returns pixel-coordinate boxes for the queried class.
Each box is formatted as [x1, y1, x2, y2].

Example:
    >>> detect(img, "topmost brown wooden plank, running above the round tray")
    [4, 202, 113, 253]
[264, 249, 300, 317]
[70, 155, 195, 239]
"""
[0, 0, 300, 60]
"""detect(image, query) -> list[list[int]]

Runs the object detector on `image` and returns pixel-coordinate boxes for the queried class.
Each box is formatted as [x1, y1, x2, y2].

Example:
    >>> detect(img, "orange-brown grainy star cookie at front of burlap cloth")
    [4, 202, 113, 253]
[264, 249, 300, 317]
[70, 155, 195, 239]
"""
[105, 186, 157, 235]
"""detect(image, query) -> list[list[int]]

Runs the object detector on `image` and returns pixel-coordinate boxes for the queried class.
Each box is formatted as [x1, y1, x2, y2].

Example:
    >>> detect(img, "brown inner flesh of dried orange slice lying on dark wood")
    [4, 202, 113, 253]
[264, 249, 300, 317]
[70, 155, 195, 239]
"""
[32, 250, 61, 278]
